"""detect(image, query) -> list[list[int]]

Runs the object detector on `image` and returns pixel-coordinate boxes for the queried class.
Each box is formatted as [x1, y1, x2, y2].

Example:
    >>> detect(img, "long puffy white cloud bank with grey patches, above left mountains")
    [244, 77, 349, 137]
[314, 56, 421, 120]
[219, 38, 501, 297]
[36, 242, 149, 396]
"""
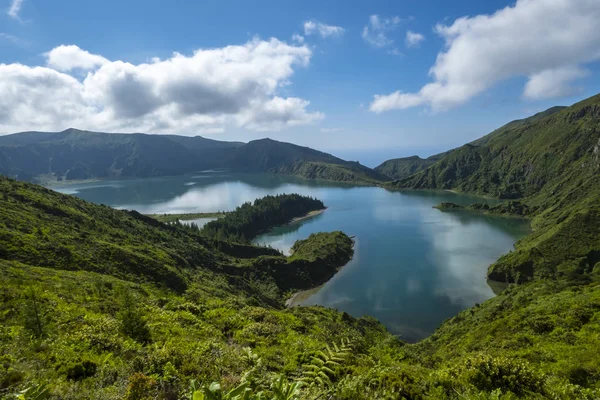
[0, 39, 323, 133]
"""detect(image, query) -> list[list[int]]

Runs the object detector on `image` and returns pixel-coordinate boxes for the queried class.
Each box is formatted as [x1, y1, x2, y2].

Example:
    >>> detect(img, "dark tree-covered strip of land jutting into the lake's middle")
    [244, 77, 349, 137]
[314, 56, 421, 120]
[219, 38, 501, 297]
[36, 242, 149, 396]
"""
[202, 194, 325, 243]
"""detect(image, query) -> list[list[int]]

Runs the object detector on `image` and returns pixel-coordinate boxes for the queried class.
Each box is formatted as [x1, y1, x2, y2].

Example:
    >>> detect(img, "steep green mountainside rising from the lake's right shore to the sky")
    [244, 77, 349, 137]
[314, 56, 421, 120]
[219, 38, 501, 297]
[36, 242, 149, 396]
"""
[389, 96, 600, 282]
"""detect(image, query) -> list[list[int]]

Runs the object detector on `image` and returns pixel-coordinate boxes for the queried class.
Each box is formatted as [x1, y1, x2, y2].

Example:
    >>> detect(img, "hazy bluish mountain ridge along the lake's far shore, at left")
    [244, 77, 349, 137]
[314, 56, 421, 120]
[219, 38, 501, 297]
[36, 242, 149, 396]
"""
[0, 129, 386, 183]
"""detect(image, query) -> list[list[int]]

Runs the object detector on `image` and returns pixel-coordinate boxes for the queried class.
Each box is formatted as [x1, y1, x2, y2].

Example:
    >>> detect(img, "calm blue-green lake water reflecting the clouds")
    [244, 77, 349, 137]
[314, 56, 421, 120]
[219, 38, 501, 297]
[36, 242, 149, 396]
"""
[53, 172, 528, 341]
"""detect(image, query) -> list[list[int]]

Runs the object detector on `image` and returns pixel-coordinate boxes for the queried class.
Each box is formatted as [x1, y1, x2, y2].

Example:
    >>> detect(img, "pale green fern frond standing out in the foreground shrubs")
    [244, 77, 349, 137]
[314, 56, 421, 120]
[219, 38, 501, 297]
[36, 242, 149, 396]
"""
[300, 339, 352, 386]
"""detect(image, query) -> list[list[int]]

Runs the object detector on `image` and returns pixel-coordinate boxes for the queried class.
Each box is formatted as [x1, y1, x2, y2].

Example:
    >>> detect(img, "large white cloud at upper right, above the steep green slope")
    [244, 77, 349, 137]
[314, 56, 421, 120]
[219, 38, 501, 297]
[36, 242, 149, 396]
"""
[370, 0, 600, 112]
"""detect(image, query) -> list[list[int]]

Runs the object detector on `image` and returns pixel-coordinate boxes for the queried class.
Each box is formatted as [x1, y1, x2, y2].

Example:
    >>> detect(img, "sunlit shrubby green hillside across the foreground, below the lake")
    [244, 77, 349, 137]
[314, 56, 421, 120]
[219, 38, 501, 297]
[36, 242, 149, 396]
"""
[0, 174, 600, 400]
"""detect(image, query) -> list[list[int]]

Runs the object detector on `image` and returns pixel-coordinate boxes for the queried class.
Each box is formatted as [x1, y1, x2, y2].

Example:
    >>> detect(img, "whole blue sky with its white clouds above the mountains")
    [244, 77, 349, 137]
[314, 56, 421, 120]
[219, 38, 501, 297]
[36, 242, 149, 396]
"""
[0, 0, 600, 165]
